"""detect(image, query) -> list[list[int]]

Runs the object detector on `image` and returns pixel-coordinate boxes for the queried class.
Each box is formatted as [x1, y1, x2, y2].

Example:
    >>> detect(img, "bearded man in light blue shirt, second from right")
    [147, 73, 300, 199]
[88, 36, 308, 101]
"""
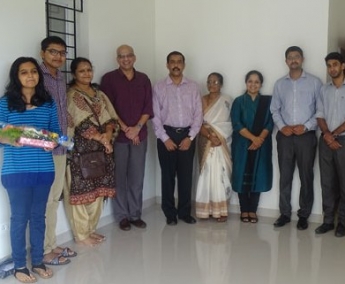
[271, 46, 322, 230]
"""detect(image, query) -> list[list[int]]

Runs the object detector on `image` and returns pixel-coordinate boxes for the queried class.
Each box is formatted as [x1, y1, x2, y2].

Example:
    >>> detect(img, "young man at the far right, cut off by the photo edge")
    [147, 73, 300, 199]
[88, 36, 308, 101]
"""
[315, 52, 345, 237]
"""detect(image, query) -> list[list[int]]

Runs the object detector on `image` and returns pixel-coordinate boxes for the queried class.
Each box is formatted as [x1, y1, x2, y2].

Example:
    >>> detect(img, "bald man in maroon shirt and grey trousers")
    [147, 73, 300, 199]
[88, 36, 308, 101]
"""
[101, 45, 153, 231]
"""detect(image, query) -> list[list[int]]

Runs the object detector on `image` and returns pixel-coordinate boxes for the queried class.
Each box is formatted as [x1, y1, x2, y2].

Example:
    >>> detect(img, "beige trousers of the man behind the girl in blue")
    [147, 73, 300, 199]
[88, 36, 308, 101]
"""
[44, 155, 66, 254]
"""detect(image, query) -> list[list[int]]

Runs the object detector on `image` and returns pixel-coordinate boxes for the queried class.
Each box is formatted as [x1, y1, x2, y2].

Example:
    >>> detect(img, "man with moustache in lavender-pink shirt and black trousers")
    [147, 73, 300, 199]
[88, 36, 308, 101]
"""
[152, 51, 203, 225]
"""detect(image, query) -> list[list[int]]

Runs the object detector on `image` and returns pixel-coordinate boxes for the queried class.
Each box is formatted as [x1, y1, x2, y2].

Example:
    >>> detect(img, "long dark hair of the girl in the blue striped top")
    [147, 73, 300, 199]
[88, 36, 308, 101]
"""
[5, 57, 53, 112]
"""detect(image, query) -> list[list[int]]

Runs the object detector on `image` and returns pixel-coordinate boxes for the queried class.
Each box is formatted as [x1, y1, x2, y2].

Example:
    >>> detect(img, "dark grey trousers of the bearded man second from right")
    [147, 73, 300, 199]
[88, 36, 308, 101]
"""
[276, 131, 317, 218]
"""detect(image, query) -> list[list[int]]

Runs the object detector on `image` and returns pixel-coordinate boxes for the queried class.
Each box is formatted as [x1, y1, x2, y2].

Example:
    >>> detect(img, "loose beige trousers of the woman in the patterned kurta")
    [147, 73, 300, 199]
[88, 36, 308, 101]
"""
[64, 163, 104, 241]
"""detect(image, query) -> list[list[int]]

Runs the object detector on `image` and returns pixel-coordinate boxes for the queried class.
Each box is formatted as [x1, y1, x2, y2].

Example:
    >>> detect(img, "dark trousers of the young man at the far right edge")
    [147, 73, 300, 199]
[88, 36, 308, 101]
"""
[319, 137, 345, 225]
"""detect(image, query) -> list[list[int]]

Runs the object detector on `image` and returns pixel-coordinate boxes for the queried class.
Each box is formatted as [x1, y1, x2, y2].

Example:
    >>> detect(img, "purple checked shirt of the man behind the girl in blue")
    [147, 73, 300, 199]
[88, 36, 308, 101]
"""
[40, 63, 67, 155]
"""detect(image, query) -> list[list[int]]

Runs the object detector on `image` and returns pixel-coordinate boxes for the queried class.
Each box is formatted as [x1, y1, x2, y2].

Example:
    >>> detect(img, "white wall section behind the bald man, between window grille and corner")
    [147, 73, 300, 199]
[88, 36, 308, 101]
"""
[85, 0, 156, 215]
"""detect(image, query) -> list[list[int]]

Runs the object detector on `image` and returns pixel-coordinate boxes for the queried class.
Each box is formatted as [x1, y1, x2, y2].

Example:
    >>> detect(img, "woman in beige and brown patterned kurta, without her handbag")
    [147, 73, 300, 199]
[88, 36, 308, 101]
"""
[65, 57, 119, 246]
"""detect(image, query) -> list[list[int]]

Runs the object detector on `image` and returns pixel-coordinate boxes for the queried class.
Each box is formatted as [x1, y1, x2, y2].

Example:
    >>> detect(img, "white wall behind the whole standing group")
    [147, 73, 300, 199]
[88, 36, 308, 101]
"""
[0, 0, 336, 259]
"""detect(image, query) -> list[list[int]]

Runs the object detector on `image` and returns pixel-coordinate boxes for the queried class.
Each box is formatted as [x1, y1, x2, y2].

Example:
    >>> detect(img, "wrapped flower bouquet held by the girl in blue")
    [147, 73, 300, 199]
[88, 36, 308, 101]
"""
[0, 122, 74, 150]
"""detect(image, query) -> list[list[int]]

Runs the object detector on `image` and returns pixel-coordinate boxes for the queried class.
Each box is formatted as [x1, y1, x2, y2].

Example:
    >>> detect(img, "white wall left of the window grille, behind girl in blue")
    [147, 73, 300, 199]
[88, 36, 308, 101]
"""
[0, 0, 46, 259]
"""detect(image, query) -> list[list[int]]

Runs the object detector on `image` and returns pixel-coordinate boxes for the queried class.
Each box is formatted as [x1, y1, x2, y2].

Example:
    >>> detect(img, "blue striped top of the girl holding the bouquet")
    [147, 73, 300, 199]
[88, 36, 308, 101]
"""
[0, 96, 61, 175]
